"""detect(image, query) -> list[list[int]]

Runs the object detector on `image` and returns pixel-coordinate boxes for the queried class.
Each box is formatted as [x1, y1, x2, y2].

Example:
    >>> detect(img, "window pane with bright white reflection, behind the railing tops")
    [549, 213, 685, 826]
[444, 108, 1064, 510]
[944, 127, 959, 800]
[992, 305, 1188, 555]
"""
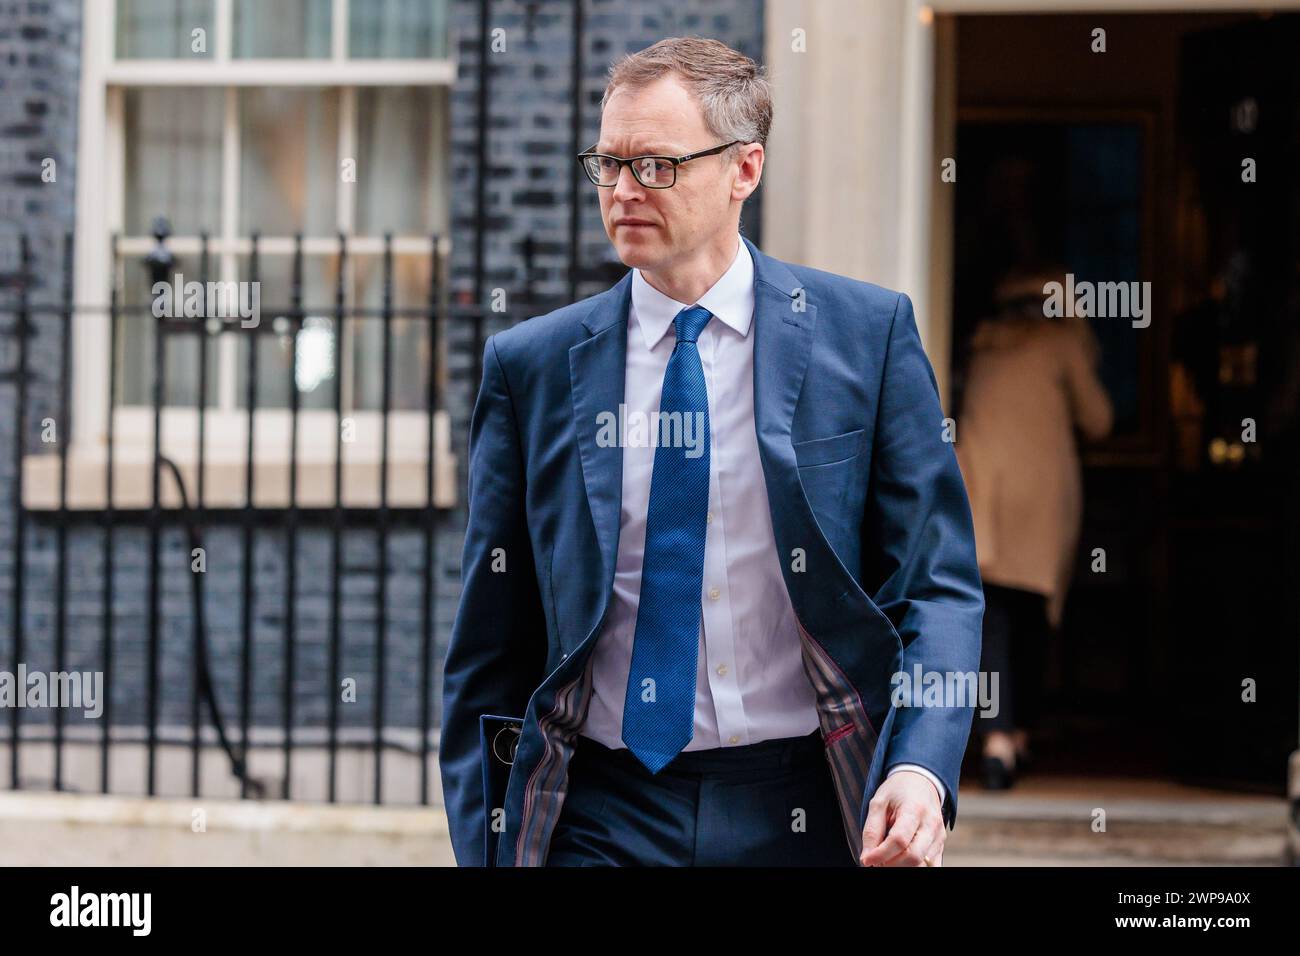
[235, 255, 338, 410]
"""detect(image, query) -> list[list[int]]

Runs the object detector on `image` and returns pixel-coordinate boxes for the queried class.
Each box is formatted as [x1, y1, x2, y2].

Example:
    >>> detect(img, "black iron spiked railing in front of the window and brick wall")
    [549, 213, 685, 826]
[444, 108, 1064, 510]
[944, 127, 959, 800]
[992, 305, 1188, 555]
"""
[0, 222, 537, 804]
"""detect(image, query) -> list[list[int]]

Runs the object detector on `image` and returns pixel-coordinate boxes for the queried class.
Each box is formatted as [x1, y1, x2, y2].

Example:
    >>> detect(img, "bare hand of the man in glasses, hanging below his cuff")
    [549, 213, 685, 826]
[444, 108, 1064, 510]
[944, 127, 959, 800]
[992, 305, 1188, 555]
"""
[859, 770, 948, 866]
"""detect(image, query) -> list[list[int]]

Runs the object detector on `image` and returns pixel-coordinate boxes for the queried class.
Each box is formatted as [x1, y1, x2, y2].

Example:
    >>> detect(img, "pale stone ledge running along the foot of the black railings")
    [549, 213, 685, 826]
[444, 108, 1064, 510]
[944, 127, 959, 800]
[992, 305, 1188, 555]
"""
[0, 792, 449, 839]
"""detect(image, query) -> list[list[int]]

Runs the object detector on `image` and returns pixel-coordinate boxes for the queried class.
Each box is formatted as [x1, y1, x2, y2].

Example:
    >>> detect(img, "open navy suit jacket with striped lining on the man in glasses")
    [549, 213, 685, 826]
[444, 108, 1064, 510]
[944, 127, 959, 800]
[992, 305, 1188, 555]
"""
[439, 237, 984, 866]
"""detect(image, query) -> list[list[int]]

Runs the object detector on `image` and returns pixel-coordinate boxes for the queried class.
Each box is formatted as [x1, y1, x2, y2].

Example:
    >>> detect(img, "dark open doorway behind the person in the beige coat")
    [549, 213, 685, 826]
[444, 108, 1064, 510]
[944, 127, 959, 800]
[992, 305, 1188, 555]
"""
[950, 14, 1300, 792]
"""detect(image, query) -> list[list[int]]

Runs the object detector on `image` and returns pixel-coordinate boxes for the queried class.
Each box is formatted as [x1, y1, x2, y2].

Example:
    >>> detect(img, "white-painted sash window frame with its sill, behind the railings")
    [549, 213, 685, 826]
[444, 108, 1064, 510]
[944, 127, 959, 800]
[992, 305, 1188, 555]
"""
[45, 0, 458, 509]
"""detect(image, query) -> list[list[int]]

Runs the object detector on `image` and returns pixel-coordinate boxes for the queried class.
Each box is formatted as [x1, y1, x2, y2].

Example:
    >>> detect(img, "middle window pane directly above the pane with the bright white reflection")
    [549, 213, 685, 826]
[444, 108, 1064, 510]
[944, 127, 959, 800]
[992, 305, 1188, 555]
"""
[239, 87, 339, 235]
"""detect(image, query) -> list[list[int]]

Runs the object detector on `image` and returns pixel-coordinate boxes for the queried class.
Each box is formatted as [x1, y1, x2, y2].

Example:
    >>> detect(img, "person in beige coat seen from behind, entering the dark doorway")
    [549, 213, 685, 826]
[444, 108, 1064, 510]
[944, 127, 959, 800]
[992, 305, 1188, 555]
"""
[956, 271, 1113, 790]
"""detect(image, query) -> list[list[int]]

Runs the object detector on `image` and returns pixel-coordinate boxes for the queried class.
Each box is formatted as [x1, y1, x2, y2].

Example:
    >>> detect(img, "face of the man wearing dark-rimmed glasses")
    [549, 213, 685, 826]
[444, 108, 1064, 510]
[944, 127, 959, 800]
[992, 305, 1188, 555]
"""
[597, 74, 748, 272]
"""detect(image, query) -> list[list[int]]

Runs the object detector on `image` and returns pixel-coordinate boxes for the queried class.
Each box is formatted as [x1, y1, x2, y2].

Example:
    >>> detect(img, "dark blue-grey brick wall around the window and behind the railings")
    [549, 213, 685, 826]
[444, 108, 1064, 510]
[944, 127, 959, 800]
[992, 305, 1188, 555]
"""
[0, 0, 762, 749]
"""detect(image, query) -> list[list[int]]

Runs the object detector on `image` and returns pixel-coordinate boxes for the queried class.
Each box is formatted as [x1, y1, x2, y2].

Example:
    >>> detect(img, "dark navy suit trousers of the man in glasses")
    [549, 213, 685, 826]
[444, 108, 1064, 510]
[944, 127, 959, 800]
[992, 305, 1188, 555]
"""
[546, 731, 858, 866]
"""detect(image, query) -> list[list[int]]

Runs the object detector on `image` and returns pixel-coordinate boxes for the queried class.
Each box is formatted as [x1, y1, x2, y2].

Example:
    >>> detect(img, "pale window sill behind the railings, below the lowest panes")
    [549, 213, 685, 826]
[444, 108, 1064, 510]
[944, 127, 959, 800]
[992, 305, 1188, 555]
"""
[22, 410, 456, 511]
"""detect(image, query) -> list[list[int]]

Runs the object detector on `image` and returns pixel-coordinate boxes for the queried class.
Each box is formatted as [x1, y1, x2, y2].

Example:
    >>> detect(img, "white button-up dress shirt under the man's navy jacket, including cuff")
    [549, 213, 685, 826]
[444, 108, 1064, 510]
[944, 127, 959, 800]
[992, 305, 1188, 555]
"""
[581, 233, 944, 803]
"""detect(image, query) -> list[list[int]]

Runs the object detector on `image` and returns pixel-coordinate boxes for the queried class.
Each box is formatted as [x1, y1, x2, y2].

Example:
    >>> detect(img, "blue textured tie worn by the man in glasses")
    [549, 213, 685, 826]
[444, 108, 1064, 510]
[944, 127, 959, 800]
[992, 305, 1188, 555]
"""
[623, 306, 712, 774]
